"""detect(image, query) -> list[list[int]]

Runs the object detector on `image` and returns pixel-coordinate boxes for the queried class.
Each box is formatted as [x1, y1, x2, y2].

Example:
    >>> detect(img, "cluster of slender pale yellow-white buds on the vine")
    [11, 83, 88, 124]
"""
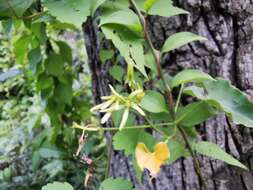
[91, 85, 145, 130]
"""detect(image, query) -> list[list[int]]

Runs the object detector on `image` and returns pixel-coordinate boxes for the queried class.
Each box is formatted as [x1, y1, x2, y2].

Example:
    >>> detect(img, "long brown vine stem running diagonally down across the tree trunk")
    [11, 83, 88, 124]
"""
[129, 0, 207, 190]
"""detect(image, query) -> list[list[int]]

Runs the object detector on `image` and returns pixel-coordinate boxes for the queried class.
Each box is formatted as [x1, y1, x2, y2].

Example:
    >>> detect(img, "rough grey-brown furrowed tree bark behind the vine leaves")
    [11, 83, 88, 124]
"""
[84, 0, 253, 190]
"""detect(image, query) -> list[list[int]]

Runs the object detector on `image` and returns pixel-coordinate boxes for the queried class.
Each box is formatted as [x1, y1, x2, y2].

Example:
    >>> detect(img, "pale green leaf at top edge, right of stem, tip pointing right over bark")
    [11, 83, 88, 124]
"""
[147, 0, 189, 17]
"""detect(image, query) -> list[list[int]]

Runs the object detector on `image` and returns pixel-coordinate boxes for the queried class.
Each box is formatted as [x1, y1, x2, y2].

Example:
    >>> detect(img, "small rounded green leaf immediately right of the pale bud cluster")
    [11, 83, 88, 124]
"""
[141, 91, 168, 113]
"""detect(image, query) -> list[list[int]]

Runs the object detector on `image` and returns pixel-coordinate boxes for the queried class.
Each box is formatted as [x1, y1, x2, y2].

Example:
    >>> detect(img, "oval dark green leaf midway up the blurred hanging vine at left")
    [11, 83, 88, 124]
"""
[44, 53, 64, 76]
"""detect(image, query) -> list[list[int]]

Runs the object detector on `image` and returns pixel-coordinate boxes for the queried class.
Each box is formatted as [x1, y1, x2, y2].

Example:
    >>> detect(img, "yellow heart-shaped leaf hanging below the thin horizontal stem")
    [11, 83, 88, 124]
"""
[135, 142, 170, 177]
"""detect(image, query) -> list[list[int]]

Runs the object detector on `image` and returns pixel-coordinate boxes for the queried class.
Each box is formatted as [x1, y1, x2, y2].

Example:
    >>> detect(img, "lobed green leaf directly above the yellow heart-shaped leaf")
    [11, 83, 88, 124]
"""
[113, 127, 155, 156]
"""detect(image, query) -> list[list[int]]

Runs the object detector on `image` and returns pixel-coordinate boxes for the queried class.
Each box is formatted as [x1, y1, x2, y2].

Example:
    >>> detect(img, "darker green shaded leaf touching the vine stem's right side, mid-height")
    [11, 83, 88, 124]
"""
[176, 101, 217, 126]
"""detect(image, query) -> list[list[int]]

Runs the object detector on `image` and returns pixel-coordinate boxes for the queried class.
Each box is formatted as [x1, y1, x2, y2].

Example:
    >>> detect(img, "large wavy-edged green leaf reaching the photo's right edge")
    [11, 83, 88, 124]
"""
[186, 79, 253, 127]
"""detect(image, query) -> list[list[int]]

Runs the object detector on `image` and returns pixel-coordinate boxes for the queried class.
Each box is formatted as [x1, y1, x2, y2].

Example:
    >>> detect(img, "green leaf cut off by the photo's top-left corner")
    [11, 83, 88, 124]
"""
[0, 0, 33, 19]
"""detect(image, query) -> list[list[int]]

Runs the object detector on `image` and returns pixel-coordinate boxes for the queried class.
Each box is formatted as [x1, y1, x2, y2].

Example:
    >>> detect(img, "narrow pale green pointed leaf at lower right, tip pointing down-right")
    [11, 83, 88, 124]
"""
[193, 141, 247, 170]
